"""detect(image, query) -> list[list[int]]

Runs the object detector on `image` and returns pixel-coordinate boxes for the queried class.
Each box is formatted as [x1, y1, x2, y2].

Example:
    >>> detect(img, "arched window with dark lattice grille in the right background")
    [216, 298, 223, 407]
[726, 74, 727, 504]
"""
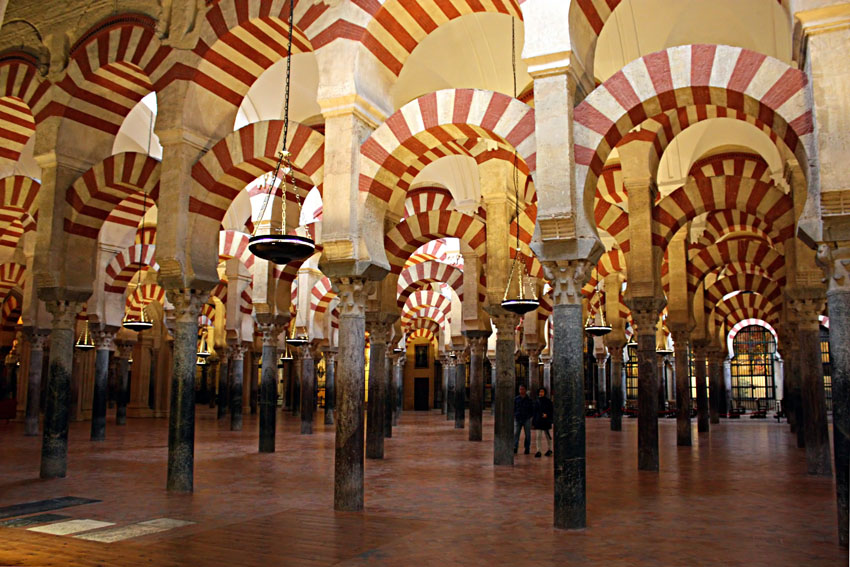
[730, 325, 776, 407]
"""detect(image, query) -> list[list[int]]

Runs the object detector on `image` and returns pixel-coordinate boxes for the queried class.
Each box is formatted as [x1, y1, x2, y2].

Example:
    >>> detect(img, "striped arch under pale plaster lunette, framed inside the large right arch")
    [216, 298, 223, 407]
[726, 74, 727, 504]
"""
[652, 176, 795, 249]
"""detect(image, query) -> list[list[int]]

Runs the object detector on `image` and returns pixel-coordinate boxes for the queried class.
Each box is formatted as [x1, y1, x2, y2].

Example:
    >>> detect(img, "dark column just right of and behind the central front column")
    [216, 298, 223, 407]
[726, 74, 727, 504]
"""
[366, 321, 392, 459]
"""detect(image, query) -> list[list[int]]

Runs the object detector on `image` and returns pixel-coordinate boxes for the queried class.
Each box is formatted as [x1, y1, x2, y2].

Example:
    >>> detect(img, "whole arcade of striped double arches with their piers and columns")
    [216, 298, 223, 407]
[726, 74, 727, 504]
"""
[0, 0, 850, 545]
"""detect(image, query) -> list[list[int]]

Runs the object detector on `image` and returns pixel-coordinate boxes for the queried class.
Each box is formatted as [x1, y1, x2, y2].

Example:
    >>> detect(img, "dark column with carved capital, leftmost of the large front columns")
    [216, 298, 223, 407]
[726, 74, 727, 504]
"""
[41, 301, 82, 478]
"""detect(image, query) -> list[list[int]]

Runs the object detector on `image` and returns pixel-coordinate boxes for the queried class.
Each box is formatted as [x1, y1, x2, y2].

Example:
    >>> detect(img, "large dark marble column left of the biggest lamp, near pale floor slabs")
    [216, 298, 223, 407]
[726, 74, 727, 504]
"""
[166, 289, 207, 492]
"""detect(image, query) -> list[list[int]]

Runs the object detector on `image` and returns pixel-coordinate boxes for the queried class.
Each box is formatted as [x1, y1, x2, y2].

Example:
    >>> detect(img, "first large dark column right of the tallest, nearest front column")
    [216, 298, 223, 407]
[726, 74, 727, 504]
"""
[630, 297, 663, 472]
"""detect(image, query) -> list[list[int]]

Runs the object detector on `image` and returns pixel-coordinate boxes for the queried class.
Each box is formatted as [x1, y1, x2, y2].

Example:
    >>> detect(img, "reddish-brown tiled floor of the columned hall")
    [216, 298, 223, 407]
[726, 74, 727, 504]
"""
[0, 406, 848, 567]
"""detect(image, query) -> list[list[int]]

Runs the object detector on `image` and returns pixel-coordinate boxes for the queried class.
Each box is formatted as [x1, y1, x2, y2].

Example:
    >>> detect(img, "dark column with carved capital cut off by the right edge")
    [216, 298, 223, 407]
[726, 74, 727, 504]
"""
[817, 243, 850, 547]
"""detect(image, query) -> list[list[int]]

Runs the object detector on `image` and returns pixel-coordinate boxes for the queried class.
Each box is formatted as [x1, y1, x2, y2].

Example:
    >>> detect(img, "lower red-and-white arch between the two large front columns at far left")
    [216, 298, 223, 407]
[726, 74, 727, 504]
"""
[65, 152, 161, 240]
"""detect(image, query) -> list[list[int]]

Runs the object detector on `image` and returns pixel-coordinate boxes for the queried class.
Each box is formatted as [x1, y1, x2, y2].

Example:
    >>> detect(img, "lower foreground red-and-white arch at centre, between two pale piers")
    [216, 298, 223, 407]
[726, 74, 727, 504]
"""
[360, 89, 537, 214]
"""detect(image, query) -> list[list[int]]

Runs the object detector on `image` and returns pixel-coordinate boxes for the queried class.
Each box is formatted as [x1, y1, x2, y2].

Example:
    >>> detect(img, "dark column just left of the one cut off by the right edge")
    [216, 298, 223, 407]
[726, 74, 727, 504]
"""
[790, 292, 835, 476]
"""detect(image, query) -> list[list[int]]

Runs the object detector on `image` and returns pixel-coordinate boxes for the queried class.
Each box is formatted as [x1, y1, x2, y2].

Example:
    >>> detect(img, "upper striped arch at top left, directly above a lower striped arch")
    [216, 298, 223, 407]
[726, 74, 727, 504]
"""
[54, 13, 171, 135]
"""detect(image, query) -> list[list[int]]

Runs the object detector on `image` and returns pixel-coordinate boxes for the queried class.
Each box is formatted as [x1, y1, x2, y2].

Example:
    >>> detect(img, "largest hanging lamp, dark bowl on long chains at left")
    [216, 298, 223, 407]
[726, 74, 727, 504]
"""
[248, 2, 316, 265]
